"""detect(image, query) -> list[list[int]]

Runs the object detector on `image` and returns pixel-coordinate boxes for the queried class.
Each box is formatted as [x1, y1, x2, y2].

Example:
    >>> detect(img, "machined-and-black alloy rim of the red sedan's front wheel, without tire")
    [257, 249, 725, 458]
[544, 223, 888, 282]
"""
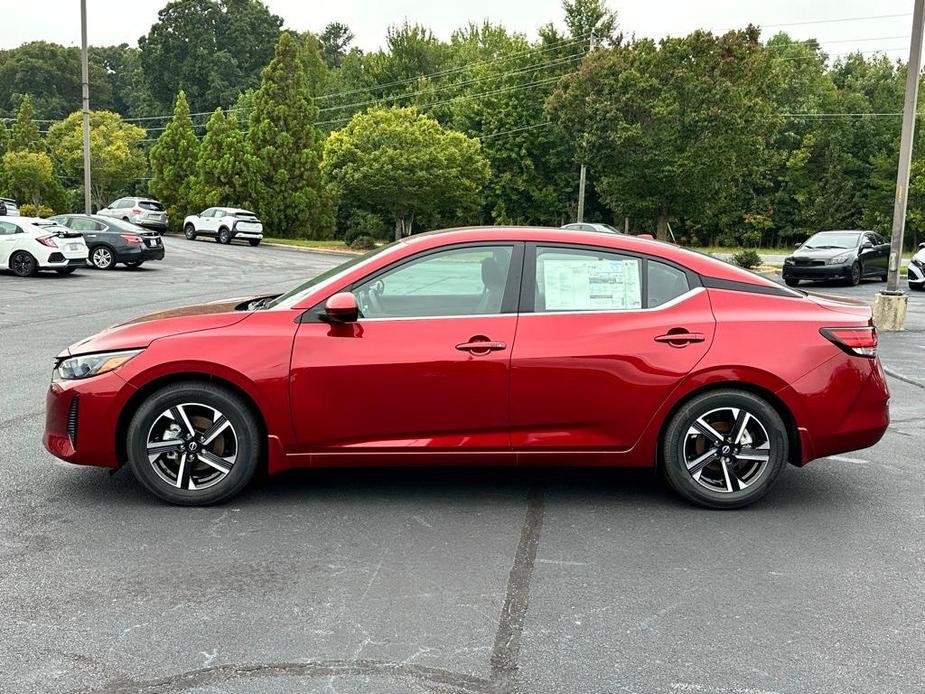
[146, 402, 238, 491]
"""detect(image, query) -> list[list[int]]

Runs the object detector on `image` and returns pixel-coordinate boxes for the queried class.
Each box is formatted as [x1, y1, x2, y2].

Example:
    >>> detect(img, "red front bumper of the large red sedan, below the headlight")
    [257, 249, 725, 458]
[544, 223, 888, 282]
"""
[42, 373, 134, 467]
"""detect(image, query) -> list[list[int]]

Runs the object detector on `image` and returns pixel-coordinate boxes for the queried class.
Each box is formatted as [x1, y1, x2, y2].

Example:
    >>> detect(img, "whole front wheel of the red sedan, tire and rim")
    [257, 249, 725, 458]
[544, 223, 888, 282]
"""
[126, 383, 260, 506]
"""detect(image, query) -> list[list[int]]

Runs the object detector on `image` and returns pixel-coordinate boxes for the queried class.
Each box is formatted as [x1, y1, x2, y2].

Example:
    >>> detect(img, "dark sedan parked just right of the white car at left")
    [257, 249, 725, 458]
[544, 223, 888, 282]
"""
[52, 214, 164, 270]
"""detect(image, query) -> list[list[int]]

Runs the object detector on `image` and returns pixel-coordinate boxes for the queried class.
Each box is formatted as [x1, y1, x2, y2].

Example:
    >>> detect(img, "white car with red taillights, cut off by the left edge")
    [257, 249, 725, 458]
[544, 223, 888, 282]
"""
[0, 217, 87, 277]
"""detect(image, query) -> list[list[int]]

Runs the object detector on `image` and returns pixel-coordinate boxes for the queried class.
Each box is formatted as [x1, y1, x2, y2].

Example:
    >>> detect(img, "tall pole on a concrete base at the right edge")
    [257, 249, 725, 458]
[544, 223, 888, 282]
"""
[874, 0, 925, 330]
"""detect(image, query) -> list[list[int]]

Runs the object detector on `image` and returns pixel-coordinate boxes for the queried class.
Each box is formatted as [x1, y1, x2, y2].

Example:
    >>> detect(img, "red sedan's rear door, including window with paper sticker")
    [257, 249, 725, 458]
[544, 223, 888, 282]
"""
[511, 244, 715, 452]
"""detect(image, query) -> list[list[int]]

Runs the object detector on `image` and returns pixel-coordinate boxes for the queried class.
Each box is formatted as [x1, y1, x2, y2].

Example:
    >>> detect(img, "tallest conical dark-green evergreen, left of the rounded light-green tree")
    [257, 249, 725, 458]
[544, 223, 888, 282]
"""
[247, 33, 334, 238]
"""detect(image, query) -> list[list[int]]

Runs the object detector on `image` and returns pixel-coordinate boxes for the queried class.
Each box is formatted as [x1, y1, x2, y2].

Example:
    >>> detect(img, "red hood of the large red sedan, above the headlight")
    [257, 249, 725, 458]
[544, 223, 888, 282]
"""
[58, 297, 259, 357]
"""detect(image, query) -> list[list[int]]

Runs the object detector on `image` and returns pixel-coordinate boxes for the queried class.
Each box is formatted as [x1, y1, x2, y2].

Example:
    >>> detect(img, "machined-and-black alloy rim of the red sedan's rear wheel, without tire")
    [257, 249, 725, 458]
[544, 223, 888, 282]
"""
[683, 407, 771, 494]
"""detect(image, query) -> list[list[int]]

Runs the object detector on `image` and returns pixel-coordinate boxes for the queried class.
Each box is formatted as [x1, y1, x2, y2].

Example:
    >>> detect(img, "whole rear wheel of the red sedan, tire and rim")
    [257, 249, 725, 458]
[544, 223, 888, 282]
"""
[661, 389, 789, 509]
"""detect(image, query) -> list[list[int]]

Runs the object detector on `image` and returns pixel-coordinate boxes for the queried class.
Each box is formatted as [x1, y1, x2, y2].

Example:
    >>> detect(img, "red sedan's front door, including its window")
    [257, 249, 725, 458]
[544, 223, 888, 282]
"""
[290, 243, 523, 453]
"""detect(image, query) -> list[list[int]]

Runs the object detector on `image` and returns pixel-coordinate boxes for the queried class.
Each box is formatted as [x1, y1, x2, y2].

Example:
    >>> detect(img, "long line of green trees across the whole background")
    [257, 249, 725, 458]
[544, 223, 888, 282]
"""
[0, 0, 925, 246]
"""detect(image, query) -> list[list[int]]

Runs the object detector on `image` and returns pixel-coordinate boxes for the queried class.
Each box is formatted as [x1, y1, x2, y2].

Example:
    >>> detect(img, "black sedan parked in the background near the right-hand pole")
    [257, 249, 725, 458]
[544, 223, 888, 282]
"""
[783, 231, 890, 287]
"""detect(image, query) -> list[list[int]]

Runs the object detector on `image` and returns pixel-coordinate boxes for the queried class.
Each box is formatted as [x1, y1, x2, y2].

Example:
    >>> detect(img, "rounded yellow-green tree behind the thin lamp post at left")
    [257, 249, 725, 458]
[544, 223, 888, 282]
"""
[46, 111, 147, 208]
